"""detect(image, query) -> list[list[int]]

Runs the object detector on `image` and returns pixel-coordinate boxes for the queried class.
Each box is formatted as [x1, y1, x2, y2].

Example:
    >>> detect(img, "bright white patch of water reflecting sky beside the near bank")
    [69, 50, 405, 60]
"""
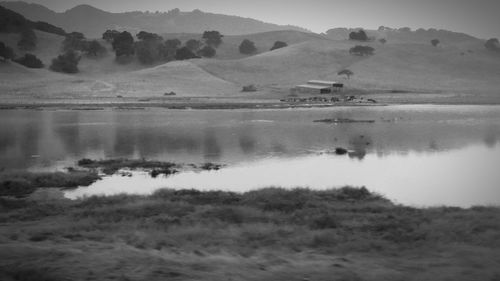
[66, 143, 500, 207]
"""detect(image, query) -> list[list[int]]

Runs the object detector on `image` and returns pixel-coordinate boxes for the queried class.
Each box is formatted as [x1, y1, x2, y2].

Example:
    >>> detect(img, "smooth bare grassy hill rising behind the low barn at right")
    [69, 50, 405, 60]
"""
[198, 35, 500, 93]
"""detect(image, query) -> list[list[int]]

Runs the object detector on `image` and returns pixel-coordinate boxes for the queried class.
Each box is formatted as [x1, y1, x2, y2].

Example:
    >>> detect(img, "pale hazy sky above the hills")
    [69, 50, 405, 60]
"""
[19, 0, 500, 38]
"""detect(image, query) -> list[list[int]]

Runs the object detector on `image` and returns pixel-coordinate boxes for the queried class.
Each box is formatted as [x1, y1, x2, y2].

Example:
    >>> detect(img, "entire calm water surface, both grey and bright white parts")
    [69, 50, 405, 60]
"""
[0, 105, 500, 206]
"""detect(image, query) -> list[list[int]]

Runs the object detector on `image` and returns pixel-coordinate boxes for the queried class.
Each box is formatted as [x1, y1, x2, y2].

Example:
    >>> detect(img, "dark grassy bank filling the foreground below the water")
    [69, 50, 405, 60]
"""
[0, 188, 500, 280]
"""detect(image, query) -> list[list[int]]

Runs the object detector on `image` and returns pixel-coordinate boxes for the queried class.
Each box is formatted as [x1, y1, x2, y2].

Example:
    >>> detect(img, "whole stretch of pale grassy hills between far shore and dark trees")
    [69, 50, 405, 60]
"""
[0, 8, 500, 104]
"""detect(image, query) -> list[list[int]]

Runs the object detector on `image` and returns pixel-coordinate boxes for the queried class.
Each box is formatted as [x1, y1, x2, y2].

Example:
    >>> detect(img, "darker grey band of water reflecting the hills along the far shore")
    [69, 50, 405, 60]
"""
[0, 106, 500, 169]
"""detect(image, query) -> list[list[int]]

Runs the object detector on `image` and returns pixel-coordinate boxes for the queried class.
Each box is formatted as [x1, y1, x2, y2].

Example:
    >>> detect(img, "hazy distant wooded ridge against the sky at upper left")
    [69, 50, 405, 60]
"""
[0, 1, 306, 38]
